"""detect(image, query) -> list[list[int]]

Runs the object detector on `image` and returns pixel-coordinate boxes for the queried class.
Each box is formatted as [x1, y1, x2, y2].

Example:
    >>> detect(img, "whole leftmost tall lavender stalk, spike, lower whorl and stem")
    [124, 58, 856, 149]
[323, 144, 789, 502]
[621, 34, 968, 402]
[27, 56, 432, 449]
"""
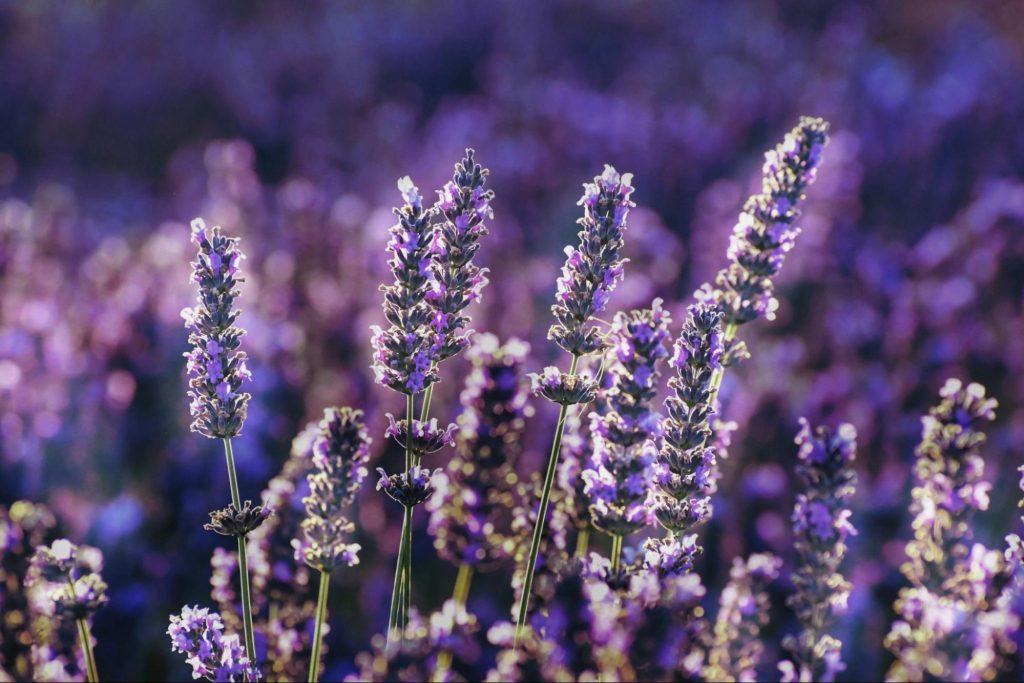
[181, 218, 266, 661]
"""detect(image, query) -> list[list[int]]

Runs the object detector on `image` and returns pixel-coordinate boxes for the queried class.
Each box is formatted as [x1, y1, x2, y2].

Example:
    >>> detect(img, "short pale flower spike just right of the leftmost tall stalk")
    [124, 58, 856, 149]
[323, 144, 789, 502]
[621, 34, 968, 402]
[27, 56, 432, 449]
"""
[295, 408, 372, 573]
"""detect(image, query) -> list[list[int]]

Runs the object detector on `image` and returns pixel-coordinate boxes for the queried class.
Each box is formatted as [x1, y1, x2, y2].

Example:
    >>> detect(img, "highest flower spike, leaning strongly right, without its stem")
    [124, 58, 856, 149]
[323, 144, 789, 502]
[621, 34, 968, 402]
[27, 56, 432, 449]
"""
[697, 117, 828, 326]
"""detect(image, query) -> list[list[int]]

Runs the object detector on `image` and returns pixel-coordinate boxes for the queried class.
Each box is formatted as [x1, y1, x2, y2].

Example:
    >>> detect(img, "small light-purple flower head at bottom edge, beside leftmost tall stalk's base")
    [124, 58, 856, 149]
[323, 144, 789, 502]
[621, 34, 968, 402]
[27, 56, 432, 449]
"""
[167, 605, 261, 682]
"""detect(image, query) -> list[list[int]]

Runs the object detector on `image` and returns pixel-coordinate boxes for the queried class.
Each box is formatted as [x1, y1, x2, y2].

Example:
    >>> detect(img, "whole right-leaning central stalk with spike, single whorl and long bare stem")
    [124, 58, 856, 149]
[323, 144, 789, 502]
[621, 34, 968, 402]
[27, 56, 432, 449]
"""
[515, 166, 634, 642]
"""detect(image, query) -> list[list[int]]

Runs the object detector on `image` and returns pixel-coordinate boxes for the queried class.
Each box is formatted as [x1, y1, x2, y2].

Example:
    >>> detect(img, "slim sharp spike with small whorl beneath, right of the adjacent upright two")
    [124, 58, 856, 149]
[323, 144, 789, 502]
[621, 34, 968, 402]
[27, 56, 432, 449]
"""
[647, 303, 722, 569]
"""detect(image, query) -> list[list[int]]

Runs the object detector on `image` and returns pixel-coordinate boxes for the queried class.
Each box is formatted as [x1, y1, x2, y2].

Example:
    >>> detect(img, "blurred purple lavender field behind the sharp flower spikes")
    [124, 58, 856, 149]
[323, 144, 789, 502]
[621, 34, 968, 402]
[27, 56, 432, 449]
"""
[0, 0, 1024, 680]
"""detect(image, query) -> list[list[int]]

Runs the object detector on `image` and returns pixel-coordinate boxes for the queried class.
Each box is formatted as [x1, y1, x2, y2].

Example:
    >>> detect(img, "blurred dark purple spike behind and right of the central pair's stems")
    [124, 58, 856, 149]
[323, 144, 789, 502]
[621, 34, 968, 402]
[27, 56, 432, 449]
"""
[427, 334, 530, 566]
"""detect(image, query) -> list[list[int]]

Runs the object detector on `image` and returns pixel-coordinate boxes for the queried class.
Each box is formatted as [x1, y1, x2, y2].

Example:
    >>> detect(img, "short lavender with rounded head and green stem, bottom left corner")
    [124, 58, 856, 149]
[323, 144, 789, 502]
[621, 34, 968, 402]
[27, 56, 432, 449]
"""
[26, 539, 108, 683]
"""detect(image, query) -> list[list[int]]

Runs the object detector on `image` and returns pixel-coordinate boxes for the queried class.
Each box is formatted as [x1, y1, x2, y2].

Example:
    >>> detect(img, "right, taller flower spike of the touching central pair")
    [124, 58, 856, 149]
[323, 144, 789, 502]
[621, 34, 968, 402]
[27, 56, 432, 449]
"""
[427, 150, 495, 361]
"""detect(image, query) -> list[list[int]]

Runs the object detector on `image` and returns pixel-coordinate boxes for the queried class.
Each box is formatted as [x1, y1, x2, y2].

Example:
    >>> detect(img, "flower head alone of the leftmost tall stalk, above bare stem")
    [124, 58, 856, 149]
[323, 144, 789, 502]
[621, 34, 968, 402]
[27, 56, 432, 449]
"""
[181, 218, 252, 438]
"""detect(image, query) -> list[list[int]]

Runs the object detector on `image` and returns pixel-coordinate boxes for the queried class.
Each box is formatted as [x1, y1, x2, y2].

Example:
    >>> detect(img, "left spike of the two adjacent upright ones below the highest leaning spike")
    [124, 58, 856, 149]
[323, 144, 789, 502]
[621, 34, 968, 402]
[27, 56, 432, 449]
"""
[583, 299, 671, 536]
